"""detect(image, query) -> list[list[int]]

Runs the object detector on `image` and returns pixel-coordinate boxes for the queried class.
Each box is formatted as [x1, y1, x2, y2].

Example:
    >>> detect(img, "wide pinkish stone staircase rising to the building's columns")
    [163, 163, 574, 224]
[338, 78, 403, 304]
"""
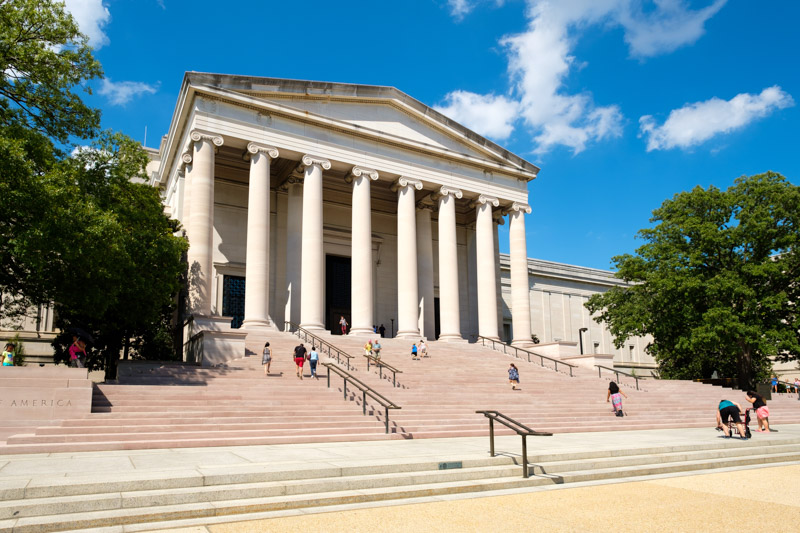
[0, 333, 800, 454]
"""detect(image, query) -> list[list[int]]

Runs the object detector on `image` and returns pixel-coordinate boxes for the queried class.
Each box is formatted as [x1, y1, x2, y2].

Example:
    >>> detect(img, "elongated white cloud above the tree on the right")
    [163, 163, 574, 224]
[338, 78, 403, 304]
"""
[639, 85, 794, 152]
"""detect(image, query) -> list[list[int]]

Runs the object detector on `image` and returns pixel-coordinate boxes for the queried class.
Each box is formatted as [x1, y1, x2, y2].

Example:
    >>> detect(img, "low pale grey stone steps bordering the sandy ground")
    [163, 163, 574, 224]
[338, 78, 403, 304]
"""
[0, 437, 800, 533]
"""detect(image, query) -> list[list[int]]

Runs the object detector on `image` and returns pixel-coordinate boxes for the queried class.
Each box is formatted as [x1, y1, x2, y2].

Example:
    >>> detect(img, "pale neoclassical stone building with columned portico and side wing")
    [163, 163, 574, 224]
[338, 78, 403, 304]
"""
[1, 72, 668, 368]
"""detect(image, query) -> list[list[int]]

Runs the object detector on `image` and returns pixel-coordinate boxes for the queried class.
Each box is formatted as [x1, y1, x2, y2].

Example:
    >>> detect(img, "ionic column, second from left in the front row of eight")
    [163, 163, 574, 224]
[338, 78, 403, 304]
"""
[242, 143, 278, 329]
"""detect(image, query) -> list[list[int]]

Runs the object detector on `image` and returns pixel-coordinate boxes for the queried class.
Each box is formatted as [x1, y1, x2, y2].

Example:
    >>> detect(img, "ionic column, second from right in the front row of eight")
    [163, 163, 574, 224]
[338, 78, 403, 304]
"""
[473, 195, 500, 340]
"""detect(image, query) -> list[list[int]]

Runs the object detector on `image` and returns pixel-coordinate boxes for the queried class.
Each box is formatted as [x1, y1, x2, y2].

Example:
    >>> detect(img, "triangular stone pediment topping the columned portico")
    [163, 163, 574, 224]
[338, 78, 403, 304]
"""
[187, 72, 539, 179]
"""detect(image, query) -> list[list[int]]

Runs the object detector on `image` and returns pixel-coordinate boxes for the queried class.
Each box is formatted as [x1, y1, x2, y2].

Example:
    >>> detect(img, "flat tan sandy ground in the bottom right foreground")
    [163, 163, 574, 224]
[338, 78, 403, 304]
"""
[153, 465, 800, 533]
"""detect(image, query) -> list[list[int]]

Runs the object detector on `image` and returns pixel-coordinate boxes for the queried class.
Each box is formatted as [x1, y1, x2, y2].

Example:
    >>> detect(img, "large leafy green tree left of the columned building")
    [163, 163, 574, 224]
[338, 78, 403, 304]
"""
[0, 0, 187, 377]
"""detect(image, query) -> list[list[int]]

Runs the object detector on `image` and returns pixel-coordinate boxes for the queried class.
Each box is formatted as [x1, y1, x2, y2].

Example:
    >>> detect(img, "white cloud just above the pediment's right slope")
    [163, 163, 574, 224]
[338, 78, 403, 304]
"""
[434, 91, 519, 140]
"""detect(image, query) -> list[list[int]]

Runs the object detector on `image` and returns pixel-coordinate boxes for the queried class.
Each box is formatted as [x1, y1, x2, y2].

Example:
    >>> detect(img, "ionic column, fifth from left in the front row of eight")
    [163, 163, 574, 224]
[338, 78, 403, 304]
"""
[392, 177, 422, 338]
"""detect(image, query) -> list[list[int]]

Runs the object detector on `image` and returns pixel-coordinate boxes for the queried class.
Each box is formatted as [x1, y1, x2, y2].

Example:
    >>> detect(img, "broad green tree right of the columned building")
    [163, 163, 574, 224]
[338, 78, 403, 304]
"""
[586, 172, 800, 386]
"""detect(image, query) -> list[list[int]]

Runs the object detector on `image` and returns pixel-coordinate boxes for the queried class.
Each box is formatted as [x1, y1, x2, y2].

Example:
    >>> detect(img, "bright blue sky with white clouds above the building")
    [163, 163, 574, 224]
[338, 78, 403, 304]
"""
[67, 0, 800, 269]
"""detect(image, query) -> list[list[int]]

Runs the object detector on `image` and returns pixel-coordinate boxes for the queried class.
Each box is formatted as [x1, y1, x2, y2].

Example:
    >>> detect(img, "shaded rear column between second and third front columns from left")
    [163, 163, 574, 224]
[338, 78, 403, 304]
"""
[284, 175, 303, 325]
